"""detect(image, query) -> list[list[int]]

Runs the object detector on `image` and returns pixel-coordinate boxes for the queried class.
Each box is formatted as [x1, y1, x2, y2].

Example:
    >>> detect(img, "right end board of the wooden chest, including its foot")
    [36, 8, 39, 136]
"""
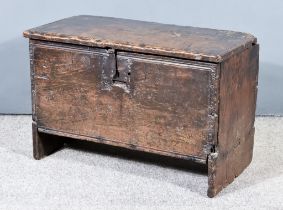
[208, 45, 259, 197]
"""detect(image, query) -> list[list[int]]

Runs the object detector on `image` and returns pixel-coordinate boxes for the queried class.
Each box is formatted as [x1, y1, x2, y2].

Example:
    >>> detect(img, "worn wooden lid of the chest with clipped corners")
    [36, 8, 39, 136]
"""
[24, 15, 256, 63]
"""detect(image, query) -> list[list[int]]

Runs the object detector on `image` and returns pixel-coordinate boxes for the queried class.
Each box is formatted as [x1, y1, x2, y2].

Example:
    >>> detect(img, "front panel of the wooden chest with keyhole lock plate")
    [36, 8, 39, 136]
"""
[33, 42, 220, 159]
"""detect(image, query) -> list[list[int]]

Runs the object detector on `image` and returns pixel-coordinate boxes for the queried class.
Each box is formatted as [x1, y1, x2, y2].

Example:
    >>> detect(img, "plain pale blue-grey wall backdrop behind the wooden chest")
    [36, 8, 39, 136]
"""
[0, 0, 283, 115]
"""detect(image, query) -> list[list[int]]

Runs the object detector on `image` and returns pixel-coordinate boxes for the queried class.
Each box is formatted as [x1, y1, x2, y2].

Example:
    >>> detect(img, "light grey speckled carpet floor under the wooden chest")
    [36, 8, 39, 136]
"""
[0, 116, 283, 209]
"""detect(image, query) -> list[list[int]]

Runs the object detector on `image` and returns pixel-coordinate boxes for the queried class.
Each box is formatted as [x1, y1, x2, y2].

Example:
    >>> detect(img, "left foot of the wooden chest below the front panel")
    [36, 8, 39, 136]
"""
[32, 122, 64, 160]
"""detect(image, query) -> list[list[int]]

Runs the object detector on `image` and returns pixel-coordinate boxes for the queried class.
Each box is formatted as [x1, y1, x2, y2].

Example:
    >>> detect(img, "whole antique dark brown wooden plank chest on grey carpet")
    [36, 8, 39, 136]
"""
[24, 16, 259, 197]
